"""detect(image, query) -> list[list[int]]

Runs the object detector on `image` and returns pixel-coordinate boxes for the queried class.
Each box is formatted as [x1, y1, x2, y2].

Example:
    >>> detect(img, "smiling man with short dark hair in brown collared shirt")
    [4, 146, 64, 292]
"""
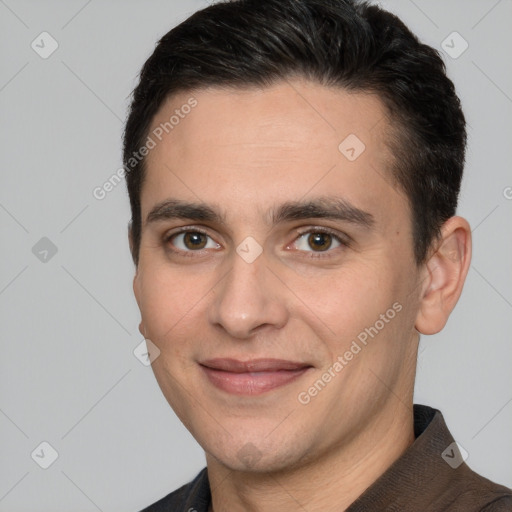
[124, 0, 512, 512]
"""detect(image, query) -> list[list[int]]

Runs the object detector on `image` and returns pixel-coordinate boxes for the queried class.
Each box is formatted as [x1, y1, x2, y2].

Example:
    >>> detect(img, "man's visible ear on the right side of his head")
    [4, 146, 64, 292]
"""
[415, 217, 471, 334]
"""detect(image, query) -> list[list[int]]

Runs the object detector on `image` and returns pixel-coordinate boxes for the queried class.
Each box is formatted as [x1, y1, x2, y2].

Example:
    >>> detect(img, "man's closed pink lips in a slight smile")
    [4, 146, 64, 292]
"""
[200, 358, 312, 396]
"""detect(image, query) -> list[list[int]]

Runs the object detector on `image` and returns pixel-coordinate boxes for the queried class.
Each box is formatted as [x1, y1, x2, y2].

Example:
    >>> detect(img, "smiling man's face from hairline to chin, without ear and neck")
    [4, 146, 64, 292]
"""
[134, 80, 420, 471]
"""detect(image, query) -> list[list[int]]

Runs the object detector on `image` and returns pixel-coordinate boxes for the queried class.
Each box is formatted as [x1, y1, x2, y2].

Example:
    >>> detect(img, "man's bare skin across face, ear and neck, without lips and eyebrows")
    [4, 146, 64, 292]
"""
[134, 79, 471, 512]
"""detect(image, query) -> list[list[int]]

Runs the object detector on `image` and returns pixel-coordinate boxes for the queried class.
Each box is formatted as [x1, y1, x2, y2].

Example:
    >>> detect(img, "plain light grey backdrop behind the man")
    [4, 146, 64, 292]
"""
[0, 0, 512, 512]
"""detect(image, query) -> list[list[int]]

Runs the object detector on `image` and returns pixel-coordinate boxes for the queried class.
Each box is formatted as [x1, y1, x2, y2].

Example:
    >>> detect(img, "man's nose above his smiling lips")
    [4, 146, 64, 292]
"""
[209, 249, 289, 339]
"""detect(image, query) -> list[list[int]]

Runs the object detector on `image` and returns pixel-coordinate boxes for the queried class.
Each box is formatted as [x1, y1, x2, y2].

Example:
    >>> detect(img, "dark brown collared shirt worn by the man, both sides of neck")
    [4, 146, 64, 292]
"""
[142, 405, 512, 512]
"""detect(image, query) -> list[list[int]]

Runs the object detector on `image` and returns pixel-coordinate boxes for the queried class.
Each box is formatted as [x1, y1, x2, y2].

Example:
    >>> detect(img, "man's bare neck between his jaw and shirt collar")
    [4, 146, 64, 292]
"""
[207, 400, 414, 512]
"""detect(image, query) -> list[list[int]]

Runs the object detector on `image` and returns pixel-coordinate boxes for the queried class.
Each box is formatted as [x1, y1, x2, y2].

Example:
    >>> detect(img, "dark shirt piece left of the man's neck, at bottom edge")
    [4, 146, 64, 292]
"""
[141, 468, 210, 512]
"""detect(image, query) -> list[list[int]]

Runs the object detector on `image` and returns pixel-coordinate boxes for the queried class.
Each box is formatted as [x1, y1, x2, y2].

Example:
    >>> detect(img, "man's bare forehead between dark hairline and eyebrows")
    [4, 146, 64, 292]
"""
[142, 80, 401, 226]
